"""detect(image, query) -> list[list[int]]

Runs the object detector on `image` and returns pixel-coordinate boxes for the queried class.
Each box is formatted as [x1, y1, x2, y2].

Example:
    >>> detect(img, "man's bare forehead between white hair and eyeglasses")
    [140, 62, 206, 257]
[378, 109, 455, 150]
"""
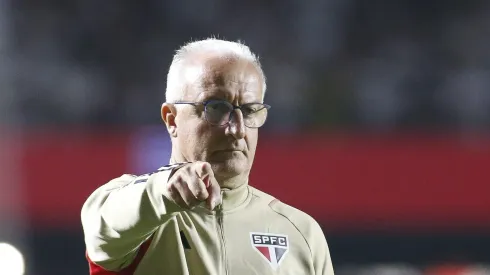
[191, 57, 263, 101]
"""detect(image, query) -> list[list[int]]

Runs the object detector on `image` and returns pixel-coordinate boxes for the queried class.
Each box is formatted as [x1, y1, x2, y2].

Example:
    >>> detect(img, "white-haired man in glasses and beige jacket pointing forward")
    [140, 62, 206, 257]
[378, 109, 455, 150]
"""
[82, 39, 334, 275]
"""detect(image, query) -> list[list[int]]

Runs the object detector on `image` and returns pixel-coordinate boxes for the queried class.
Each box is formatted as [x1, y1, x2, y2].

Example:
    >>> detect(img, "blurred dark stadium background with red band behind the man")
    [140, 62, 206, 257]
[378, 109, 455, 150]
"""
[0, 0, 490, 275]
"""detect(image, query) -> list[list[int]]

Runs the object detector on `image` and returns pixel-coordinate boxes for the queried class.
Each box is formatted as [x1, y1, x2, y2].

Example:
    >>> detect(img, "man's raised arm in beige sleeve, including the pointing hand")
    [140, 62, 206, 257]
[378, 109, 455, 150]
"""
[81, 162, 221, 271]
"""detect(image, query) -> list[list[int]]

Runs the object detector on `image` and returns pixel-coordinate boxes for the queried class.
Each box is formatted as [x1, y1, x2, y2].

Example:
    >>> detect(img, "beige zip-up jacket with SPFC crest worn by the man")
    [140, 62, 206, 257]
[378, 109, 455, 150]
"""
[82, 166, 334, 275]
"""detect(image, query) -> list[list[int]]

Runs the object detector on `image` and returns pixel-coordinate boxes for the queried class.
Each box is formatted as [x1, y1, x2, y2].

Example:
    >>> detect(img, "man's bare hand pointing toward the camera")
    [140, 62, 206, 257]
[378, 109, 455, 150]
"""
[163, 161, 221, 210]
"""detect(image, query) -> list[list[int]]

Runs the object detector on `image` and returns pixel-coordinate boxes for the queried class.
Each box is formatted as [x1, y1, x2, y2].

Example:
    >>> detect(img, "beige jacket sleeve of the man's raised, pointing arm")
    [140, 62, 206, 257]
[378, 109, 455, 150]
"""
[81, 168, 184, 271]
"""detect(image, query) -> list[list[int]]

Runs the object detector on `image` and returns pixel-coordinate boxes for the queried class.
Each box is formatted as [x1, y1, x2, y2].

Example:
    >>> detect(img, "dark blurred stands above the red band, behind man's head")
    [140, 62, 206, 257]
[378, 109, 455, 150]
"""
[0, 0, 490, 130]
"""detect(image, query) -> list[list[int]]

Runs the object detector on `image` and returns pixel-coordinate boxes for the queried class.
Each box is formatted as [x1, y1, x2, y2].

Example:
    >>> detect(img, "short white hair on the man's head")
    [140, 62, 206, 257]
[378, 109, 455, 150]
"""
[165, 38, 266, 103]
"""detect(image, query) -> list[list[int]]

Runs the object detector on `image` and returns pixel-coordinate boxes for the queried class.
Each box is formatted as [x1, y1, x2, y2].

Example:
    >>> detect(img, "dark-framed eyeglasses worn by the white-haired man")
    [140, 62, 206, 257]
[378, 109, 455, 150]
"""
[173, 100, 271, 128]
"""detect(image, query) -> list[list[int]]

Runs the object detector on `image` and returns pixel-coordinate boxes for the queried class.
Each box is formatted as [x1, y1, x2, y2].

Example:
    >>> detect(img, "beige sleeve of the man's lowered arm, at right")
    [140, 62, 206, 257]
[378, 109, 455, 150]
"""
[309, 220, 334, 275]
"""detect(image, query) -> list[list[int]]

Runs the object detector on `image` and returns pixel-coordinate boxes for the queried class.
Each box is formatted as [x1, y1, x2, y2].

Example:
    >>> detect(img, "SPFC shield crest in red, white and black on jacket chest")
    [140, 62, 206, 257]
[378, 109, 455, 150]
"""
[250, 232, 289, 269]
